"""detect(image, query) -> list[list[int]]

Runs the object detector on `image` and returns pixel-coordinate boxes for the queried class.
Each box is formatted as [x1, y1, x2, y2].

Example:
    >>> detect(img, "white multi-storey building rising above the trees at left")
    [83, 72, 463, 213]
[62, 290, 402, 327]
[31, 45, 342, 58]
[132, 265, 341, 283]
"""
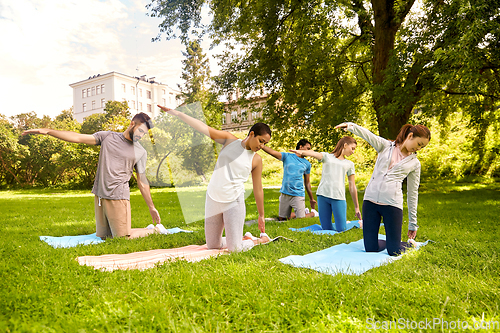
[69, 72, 181, 122]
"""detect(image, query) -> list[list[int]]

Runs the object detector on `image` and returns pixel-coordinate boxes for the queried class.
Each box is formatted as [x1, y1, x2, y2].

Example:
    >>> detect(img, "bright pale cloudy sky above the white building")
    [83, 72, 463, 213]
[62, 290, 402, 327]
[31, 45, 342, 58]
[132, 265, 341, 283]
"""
[0, 0, 217, 118]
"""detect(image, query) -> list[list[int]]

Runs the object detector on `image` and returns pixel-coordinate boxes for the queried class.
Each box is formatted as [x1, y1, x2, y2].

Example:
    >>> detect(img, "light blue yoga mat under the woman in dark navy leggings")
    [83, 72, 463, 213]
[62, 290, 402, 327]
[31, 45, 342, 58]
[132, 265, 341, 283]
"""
[280, 235, 429, 275]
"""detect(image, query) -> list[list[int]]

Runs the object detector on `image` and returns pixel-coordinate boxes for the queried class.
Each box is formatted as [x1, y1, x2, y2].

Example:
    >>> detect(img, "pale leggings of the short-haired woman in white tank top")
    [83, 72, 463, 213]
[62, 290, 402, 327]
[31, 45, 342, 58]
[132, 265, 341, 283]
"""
[205, 193, 254, 252]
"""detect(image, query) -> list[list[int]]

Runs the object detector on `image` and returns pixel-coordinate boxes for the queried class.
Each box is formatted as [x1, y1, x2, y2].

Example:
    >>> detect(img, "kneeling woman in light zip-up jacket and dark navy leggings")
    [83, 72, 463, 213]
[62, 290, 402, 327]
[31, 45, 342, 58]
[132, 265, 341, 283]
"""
[335, 123, 431, 256]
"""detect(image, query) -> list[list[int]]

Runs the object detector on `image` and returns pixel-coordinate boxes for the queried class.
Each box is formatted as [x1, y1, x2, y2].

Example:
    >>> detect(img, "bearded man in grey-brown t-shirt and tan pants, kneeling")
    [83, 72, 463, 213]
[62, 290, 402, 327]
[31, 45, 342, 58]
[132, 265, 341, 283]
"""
[23, 112, 161, 239]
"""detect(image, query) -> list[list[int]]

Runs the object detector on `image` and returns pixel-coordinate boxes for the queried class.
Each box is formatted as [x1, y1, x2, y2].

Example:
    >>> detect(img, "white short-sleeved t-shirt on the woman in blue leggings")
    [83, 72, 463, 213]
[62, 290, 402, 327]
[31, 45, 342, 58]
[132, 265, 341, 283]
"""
[316, 153, 354, 200]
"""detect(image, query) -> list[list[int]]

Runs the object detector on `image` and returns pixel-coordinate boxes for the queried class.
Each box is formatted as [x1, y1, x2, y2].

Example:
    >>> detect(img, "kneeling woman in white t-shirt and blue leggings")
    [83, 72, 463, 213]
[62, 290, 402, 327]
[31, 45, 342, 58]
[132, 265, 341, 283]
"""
[291, 136, 361, 231]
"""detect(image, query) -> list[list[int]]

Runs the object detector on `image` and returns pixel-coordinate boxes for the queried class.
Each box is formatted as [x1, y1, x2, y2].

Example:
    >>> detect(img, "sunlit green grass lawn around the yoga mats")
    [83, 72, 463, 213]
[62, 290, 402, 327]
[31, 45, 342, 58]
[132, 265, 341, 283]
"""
[0, 182, 500, 332]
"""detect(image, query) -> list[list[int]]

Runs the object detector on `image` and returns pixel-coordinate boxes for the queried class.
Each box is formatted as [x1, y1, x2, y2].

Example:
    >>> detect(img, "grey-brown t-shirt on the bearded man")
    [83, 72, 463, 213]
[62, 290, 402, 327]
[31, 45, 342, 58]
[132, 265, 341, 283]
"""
[92, 131, 147, 200]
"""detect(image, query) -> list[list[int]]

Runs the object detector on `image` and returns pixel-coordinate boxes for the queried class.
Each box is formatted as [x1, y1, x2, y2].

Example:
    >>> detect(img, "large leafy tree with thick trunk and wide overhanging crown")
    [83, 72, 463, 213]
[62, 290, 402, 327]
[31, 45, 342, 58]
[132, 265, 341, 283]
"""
[148, 0, 500, 138]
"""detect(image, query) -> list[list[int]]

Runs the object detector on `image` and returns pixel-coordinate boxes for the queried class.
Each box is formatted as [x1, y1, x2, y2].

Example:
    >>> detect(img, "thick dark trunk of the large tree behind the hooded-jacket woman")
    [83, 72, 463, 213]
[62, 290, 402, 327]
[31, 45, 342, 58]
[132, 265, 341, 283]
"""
[372, 0, 416, 140]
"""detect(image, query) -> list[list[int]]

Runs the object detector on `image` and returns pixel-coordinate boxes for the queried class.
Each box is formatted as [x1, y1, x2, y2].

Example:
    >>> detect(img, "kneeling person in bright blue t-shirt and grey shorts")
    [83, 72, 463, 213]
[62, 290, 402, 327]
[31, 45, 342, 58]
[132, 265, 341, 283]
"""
[262, 139, 318, 221]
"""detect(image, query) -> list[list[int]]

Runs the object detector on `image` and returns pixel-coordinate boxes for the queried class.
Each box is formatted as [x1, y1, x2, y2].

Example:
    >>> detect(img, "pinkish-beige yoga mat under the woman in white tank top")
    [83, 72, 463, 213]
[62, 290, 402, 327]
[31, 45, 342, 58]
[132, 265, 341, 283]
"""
[76, 244, 228, 272]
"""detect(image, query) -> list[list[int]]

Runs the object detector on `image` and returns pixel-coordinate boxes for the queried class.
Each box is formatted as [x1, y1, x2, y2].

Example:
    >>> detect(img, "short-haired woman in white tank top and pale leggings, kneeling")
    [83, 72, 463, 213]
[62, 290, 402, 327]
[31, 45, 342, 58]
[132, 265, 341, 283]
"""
[158, 105, 271, 252]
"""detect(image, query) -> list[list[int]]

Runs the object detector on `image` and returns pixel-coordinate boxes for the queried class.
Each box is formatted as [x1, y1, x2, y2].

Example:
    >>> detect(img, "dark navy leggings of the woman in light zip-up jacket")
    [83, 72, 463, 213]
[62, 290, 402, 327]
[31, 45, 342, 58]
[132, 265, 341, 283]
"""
[363, 200, 410, 256]
